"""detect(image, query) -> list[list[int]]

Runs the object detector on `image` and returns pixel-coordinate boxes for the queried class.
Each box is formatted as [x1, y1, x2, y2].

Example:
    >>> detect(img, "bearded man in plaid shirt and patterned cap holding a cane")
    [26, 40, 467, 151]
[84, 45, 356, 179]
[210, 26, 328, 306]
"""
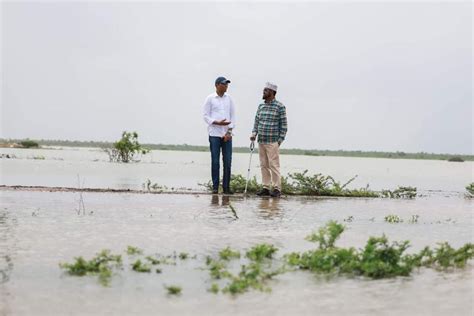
[250, 82, 288, 197]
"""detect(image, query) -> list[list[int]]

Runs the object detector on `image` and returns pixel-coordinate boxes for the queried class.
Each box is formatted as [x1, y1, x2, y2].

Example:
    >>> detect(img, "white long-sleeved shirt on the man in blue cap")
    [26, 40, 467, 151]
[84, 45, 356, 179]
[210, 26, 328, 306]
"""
[204, 92, 235, 137]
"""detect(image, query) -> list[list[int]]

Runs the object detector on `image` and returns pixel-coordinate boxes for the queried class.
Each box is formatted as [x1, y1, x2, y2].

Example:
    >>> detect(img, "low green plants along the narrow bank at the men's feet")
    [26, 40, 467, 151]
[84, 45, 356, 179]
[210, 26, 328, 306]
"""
[199, 170, 417, 199]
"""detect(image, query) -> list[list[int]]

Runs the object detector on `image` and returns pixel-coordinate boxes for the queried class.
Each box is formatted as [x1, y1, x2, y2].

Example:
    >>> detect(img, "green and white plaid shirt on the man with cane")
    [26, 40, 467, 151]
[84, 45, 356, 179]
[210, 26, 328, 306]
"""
[252, 99, 288, 144]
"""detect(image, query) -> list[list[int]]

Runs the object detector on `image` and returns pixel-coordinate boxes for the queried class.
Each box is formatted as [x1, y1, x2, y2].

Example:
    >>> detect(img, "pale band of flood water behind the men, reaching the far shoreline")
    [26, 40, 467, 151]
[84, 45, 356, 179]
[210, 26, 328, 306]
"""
[0, 148, 474, 195]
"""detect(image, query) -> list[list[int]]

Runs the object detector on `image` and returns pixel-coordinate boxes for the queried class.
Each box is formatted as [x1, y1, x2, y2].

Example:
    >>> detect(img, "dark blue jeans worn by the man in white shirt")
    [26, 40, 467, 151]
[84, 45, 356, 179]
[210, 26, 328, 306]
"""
[209, 136, 232, 191]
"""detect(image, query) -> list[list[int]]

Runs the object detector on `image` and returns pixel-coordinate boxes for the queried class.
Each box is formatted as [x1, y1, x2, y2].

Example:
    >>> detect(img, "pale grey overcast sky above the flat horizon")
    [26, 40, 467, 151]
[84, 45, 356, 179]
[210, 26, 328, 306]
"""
[0, 2, 474, 154]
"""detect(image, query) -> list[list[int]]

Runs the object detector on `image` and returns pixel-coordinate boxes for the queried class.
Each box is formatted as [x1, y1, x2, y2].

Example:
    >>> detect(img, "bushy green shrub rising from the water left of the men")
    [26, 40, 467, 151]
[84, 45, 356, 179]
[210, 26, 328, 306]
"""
[104, 131, 150, 163]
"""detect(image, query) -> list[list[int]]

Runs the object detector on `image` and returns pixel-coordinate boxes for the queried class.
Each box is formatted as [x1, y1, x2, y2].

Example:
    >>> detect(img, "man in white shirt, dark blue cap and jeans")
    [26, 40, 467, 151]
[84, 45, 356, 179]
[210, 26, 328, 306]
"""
[204, 77, 235, 194]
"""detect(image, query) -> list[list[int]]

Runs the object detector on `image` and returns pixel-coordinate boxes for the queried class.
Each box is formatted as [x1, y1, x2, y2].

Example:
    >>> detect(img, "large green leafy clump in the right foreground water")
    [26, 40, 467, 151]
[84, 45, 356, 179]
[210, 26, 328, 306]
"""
[286, 222, 474, 279]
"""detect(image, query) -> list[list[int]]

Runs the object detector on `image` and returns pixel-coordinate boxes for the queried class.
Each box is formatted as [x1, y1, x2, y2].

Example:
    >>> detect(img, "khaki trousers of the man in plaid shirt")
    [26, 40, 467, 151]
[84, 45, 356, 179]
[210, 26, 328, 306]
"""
[258, 143, 281, 191]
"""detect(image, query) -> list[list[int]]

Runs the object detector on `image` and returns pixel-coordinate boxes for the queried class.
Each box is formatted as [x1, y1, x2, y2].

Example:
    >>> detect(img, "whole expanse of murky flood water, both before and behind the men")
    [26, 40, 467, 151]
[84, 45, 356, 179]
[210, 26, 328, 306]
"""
[0, 149, 474, 315]
